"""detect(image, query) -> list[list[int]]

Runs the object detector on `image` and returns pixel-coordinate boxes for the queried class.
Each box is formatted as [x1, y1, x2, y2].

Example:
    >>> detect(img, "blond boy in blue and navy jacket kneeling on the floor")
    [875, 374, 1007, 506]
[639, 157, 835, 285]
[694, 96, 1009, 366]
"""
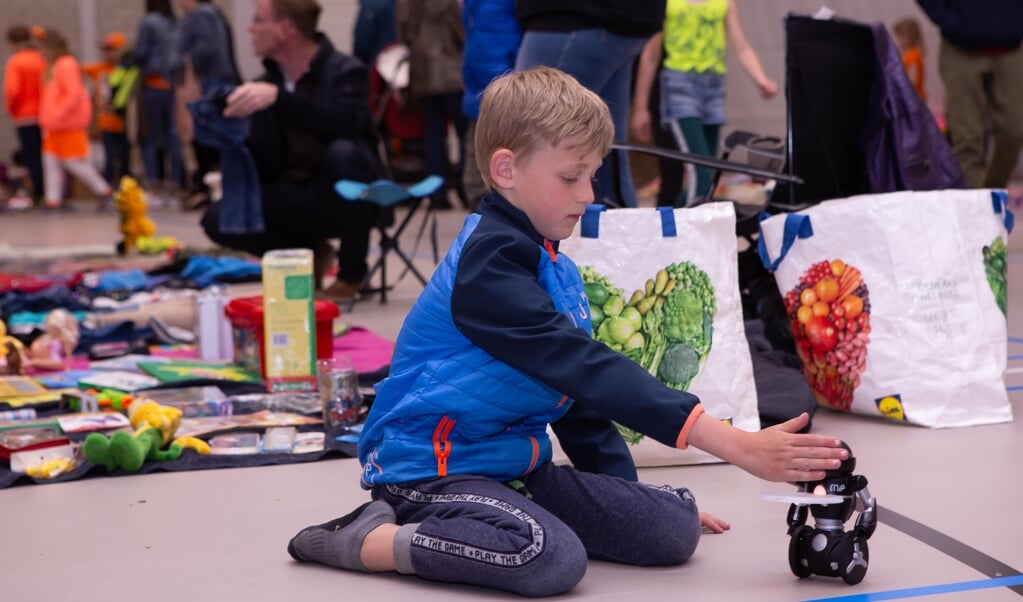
[287, 67, 847, 597]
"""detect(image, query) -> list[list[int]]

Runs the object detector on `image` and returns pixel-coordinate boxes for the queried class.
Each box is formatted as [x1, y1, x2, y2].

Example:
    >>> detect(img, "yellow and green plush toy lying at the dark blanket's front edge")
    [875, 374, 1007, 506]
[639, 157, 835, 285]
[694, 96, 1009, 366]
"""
[82, 400, 210, 472]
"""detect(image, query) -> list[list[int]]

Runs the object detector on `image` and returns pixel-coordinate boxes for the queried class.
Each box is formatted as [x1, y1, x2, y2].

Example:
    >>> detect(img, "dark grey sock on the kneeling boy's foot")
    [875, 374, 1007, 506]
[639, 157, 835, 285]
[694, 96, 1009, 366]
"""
[287, 500, 396, 572]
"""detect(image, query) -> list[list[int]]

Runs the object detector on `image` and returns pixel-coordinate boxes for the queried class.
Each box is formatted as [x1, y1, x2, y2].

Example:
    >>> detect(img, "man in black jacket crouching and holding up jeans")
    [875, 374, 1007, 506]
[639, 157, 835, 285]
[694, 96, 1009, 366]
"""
[203, 0, 384, 299]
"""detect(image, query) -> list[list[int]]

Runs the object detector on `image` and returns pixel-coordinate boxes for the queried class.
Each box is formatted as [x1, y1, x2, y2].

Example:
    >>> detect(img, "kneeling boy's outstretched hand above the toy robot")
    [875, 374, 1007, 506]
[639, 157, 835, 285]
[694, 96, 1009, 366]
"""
[687, 413, 849, 482]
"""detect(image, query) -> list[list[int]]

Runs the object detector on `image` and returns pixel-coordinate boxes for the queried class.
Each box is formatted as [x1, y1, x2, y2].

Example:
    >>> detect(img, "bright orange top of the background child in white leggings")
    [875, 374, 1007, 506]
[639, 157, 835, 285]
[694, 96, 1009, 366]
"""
[39, 54, 92, 131]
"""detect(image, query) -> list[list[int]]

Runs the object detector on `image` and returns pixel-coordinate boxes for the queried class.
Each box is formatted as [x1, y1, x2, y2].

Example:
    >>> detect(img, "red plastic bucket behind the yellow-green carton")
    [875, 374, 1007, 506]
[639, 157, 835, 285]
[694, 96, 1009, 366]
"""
[224, 295, 341, 379]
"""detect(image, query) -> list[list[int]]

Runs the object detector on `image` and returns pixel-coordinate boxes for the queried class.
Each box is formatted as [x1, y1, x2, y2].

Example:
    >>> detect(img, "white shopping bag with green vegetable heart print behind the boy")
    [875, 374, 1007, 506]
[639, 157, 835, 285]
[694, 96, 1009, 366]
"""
[554, 203, 760, 466]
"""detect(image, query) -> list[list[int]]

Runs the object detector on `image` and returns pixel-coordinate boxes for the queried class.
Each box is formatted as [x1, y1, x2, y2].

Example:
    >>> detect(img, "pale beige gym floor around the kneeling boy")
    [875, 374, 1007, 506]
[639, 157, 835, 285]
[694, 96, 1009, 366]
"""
[0, 202, 1023, 602]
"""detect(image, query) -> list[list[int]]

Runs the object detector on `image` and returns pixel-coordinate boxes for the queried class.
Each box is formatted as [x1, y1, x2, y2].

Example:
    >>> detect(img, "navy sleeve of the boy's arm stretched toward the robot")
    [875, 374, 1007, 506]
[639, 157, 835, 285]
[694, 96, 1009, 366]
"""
[451, 219, 700, 447]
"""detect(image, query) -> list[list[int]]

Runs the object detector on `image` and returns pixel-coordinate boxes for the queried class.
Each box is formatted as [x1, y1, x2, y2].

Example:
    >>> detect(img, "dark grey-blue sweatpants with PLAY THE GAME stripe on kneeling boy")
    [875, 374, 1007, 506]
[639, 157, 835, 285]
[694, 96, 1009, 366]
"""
[372, 463, 701, 596]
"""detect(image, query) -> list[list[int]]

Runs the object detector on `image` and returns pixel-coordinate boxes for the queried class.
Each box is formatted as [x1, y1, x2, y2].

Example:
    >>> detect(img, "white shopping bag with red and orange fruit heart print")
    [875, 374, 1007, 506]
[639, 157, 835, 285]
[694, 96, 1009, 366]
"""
[759, 190, 1013, 427]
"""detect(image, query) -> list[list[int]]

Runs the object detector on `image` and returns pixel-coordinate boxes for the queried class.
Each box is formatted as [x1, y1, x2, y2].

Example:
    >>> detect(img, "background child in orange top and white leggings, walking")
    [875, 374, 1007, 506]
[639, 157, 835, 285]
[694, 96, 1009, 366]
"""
[38, 30, 113, 209]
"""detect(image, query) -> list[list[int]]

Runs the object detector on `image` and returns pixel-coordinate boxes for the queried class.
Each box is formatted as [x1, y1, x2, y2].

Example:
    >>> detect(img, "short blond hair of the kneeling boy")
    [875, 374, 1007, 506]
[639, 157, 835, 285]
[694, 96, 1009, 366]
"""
[476, 67, 615, 188]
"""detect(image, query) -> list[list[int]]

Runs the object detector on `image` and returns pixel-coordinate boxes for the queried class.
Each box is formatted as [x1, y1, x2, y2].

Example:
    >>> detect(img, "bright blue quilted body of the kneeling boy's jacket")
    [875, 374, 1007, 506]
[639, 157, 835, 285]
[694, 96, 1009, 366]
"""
[359, 214, 590, 488]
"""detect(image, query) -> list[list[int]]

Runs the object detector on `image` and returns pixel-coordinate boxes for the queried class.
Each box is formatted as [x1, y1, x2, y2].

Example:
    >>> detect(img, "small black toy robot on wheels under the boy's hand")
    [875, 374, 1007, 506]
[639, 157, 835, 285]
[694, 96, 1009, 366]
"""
[788, 443, 878, 586]
